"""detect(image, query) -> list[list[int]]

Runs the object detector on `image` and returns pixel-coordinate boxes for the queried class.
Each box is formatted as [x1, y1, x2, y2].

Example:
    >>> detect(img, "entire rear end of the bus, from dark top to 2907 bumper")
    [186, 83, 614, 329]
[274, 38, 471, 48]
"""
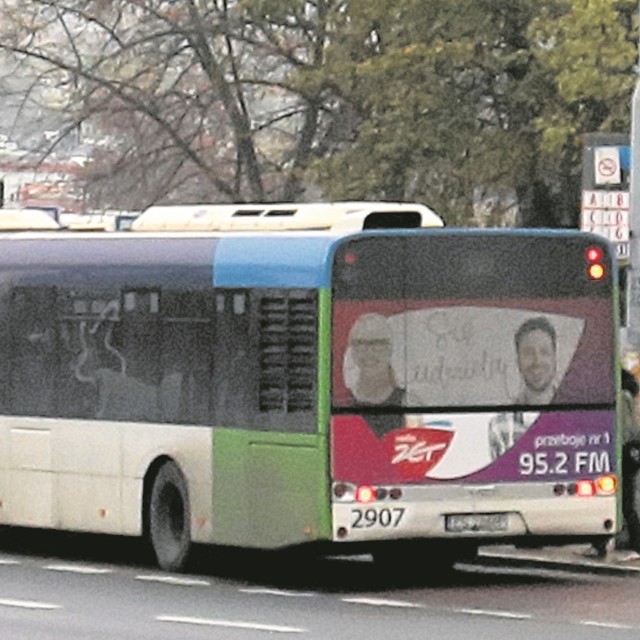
[330, 230, 620, 562]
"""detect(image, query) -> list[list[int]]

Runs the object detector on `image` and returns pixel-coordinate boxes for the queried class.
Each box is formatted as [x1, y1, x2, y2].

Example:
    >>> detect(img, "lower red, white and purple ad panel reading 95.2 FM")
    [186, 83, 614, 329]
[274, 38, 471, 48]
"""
[332, 410, 616, 484]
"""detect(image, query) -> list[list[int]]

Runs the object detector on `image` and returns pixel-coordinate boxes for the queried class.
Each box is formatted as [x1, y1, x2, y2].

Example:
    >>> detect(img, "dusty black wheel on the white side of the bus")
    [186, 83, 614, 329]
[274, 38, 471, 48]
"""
[149, 462, 191, 571]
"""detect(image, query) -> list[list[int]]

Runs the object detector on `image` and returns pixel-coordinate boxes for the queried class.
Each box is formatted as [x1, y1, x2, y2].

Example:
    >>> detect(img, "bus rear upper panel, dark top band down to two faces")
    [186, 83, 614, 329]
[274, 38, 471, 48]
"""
[333, 232, 615, 410]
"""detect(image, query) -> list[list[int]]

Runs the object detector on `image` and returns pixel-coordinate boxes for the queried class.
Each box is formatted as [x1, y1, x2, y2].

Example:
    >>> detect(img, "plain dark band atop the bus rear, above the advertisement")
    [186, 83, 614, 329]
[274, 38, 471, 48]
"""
[334, 230, 614, 300]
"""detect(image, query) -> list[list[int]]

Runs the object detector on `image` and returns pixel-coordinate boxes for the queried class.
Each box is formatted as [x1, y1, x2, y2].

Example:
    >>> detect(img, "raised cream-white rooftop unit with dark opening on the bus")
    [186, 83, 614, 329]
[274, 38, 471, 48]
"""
[131, 201, 444, 232]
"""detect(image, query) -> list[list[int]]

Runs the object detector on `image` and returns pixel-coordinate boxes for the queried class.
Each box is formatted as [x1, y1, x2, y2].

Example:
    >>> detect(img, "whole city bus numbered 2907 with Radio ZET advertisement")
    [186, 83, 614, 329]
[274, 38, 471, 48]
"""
[0, 203, 621, 571]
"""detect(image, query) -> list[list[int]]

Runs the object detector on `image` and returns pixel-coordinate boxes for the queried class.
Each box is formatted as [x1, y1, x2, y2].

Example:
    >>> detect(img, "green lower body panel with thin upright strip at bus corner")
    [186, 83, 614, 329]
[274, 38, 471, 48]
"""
[212, 290, 331, 549]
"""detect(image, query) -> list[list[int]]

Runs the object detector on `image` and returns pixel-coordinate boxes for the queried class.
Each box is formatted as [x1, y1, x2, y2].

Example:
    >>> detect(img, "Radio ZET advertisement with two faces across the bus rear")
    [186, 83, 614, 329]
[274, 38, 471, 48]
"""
[333, 299, 615, 482]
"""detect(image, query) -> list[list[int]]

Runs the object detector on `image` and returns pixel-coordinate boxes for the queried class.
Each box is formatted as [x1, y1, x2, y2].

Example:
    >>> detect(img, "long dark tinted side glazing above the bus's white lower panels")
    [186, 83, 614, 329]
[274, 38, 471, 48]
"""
[0, 287, 218, 424]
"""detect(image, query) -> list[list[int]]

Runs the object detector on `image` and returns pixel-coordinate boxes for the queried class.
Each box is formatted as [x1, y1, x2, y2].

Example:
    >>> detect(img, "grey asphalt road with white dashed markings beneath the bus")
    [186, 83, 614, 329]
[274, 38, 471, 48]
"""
[0, 533, 640, 640]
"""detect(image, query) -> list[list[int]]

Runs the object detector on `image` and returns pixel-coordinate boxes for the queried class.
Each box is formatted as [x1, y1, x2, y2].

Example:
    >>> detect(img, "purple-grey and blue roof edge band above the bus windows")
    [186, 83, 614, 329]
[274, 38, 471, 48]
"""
[0, 228, 616, 288]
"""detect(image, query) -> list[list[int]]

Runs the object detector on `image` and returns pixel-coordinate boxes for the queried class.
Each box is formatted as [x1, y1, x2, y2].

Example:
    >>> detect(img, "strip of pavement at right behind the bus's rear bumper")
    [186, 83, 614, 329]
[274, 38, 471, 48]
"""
[479, 544, 640, 577]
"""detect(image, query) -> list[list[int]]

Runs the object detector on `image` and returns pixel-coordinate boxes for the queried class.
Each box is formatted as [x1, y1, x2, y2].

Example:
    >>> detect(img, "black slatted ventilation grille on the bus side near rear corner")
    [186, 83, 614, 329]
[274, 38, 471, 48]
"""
[259, 295, 316, 413]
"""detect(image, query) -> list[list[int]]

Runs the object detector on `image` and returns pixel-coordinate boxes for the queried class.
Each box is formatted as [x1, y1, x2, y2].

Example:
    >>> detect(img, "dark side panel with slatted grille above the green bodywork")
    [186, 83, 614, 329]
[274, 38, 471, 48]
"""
[213, 289, 317, 432]
